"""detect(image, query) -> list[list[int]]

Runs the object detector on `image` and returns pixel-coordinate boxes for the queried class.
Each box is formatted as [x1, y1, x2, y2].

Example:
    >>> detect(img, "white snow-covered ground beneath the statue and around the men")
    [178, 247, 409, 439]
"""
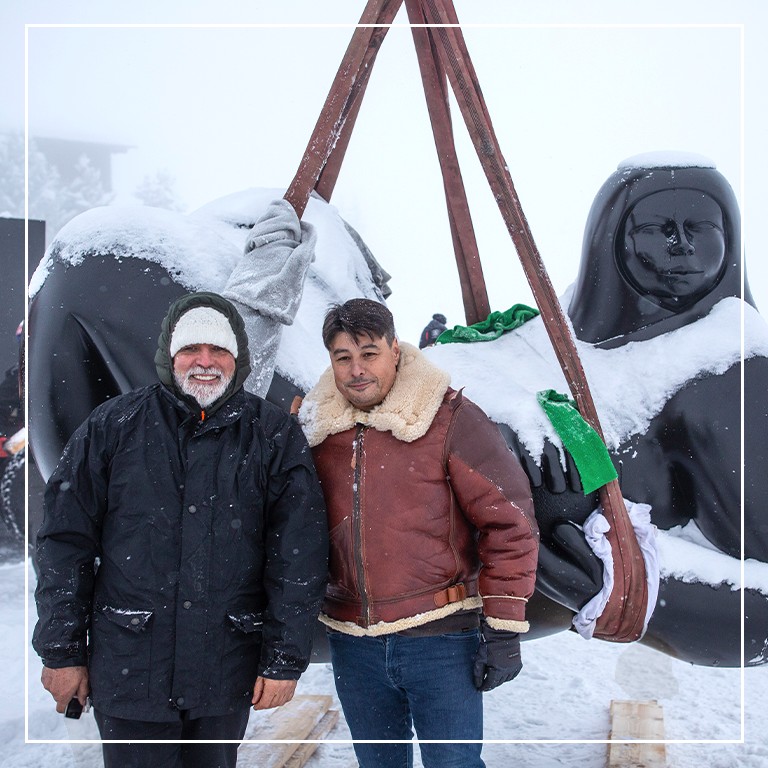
[0, 563, 768, 768]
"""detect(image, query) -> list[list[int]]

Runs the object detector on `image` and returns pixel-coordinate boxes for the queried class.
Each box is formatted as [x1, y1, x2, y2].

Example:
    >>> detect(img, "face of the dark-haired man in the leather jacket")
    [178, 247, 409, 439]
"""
[328, 333, 400, 411]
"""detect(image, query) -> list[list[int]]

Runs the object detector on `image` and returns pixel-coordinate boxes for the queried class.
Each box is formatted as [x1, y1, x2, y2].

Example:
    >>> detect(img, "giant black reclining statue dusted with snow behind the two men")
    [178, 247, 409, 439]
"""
[29, 164, 768, 665]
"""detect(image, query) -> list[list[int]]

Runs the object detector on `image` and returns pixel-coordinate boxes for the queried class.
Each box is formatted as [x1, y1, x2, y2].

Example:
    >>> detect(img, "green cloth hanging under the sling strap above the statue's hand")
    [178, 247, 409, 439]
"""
[536, 389, 617, 495]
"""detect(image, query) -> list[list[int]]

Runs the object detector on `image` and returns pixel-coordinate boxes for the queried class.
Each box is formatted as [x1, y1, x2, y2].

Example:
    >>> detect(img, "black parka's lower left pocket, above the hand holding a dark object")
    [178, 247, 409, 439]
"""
[90, 606, 152, 702]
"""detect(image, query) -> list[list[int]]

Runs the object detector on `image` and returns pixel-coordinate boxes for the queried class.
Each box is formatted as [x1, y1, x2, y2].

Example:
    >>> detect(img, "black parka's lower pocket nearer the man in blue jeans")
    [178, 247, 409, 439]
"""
[220, 611, 264, 700]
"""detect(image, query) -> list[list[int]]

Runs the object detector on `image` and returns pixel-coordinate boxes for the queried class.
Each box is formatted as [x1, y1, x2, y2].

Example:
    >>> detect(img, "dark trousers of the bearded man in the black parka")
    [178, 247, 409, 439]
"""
[93, 709, 250, 768]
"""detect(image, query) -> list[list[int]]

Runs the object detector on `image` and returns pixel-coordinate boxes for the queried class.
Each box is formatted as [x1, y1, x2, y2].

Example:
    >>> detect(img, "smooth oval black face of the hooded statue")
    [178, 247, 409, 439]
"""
[618, 189, 725, 311]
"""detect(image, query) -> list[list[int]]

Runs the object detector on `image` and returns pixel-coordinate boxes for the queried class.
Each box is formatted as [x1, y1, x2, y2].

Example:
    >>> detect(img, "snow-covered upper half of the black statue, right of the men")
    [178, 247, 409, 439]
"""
[428, 155, 768, 666]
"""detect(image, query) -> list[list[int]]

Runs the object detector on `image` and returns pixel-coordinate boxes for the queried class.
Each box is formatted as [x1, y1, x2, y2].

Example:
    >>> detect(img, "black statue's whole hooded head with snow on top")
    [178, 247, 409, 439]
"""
[568, 154, 754, 348]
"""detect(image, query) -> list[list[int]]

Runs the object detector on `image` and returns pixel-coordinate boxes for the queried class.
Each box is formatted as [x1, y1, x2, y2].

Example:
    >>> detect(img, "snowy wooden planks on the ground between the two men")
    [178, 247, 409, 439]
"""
[237, 695, 339, 768]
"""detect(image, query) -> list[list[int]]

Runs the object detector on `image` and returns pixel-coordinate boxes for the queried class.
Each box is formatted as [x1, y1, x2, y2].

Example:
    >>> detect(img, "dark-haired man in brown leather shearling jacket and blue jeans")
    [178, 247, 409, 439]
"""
[299, 299, 538, 768]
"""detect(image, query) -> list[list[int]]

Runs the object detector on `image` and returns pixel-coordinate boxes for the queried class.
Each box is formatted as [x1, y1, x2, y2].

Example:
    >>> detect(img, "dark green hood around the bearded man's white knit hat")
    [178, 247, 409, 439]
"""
[155, 291, 251, 416]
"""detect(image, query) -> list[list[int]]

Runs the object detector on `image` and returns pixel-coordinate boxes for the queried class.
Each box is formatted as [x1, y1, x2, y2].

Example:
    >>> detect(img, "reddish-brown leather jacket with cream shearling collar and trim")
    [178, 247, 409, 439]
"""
[299, 344, 538, 635]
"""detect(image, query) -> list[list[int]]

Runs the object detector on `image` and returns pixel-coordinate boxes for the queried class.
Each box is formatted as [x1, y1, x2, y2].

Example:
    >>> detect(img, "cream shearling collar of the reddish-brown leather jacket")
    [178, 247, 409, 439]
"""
[299, 342, 451, 447]
